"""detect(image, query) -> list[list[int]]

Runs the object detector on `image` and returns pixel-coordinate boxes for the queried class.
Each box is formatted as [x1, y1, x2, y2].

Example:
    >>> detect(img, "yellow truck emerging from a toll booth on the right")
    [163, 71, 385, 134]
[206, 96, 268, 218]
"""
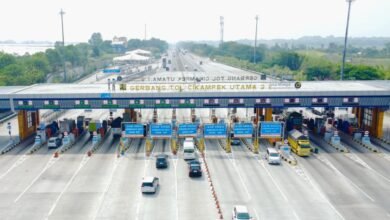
[287, 129, 311, 156]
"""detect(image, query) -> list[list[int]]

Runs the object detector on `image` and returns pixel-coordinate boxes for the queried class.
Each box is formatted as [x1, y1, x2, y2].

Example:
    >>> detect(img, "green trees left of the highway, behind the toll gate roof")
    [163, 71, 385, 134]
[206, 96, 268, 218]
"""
[0, 33, 168, 86]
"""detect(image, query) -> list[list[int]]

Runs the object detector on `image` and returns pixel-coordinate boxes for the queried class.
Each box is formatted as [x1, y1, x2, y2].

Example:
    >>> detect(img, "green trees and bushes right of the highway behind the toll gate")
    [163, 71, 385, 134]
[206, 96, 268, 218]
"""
[179, 42, 390, 80]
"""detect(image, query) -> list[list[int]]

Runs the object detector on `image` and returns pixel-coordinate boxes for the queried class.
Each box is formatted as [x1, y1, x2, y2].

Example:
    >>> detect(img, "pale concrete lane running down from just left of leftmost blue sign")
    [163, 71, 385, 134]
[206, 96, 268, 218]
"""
[49, 137, 119, 219]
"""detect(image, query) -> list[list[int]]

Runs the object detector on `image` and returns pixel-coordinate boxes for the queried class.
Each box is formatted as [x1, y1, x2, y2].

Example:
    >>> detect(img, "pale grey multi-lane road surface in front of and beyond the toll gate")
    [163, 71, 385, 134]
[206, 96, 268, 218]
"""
[0, 52, 390, 220]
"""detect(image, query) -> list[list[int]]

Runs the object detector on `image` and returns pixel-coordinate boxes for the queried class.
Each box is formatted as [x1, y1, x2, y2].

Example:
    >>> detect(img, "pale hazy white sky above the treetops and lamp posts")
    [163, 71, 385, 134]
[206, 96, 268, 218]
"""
[0, 0, 390, 43]
